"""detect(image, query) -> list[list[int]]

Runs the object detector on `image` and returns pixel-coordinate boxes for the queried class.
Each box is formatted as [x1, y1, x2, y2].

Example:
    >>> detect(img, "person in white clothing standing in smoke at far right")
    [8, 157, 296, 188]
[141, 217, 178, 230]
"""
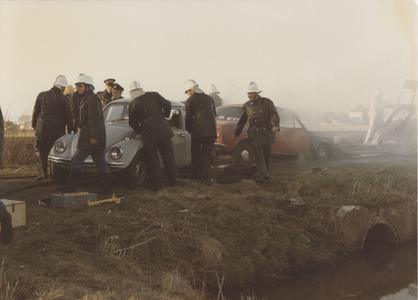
[364, 89, 396, 146]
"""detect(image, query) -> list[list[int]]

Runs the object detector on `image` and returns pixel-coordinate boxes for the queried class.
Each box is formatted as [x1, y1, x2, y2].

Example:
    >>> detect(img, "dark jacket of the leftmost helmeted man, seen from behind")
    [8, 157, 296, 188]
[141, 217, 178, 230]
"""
[32, 87, 73, 140]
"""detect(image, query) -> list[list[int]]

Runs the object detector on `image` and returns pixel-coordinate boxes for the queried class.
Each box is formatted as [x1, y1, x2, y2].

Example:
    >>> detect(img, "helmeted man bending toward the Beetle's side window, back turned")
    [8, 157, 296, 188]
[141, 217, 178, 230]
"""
[129, 81, 181, 191]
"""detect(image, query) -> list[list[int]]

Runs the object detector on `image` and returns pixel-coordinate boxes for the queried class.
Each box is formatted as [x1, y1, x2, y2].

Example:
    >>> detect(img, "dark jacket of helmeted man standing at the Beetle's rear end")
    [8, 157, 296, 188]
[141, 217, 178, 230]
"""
[186, 93, 216, 139]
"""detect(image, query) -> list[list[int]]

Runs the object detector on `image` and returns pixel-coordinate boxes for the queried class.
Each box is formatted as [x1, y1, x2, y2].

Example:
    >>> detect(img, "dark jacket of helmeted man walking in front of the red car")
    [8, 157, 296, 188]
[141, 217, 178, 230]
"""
[234, 97, 280, 147]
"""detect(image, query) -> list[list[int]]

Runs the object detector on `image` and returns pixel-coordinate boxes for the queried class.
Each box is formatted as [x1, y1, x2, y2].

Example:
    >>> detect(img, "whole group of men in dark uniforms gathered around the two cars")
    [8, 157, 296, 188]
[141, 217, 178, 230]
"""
[32, 74, 280, 194]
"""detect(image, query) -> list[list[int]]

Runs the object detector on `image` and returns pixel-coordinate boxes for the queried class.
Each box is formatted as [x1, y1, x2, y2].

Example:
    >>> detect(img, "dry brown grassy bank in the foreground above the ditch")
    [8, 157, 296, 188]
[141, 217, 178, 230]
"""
[0, 160, 417, 300]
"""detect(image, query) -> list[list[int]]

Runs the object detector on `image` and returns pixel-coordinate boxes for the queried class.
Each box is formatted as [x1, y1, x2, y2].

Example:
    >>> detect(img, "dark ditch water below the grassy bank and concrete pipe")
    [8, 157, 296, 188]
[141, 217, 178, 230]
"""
[220, 242, 417, 300]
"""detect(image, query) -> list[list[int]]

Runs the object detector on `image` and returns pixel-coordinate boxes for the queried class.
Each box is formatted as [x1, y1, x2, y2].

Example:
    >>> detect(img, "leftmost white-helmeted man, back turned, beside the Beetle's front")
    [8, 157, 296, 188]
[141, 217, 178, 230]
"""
[32, 75, 72, 180]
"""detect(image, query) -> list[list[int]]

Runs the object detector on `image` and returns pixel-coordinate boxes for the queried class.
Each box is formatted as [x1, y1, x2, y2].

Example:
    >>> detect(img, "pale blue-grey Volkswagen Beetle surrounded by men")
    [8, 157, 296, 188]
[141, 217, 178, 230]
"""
[48, 98, 191, 188]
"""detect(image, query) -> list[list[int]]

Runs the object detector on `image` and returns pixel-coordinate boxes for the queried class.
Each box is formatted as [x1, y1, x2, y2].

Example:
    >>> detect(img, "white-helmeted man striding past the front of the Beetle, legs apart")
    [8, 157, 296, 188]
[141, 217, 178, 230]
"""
[57, 74, 112, 194]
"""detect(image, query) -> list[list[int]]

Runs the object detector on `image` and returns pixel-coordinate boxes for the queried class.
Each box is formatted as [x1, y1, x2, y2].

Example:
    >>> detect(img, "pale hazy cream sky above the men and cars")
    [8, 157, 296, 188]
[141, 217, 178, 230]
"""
[0, 0, 417, 126]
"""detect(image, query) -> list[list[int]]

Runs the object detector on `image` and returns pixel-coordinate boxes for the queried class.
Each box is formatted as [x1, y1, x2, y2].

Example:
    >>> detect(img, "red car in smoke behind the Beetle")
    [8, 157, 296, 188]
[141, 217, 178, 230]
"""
[215, 104, 336, 166]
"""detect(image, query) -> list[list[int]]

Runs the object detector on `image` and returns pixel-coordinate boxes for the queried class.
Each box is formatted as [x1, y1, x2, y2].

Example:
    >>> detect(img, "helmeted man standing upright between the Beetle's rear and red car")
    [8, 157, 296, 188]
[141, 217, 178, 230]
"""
[184, 80, 216, 184]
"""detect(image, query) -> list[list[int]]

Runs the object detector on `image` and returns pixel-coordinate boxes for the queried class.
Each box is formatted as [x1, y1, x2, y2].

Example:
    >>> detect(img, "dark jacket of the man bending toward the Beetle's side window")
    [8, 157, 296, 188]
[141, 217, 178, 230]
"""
[129, 92, 174, 148]
